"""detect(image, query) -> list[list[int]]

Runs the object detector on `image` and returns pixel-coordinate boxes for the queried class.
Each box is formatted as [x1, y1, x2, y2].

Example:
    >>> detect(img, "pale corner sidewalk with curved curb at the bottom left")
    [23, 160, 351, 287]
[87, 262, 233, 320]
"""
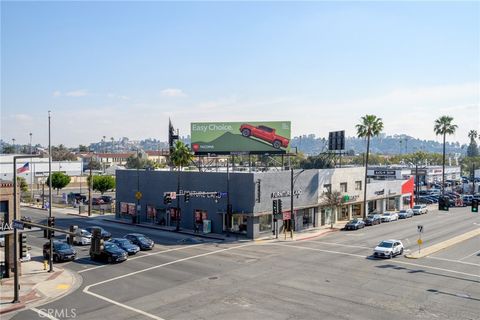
[0, 257, 82, 319]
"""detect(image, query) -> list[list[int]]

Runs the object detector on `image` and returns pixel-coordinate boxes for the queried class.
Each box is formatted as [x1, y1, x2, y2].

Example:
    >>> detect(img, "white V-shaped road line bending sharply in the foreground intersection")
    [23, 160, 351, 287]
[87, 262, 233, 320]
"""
[83, 243, 255, 320]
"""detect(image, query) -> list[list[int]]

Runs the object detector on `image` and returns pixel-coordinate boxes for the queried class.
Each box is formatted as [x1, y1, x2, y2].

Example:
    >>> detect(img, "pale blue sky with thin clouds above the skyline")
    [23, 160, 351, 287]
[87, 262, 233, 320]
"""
[1, 2, 480, 146]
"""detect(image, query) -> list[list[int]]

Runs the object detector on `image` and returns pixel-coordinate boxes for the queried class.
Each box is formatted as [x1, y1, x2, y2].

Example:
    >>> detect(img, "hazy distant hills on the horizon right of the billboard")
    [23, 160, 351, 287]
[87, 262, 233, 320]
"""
[291, 134, 467, 155]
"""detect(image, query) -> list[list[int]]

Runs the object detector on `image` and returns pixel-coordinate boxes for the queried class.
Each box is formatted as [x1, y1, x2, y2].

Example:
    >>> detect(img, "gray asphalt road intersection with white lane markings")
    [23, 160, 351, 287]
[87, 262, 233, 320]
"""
[7, 207, 480, 320]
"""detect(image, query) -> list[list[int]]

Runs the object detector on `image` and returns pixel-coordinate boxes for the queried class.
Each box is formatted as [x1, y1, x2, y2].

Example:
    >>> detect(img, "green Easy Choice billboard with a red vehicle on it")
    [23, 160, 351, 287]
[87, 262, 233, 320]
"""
[191, 121, 291, 154]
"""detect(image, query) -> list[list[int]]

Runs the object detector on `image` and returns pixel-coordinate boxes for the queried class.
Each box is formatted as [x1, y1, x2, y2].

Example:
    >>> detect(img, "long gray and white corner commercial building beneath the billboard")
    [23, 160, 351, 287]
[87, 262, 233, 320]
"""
[116, 168, 413, 239]
